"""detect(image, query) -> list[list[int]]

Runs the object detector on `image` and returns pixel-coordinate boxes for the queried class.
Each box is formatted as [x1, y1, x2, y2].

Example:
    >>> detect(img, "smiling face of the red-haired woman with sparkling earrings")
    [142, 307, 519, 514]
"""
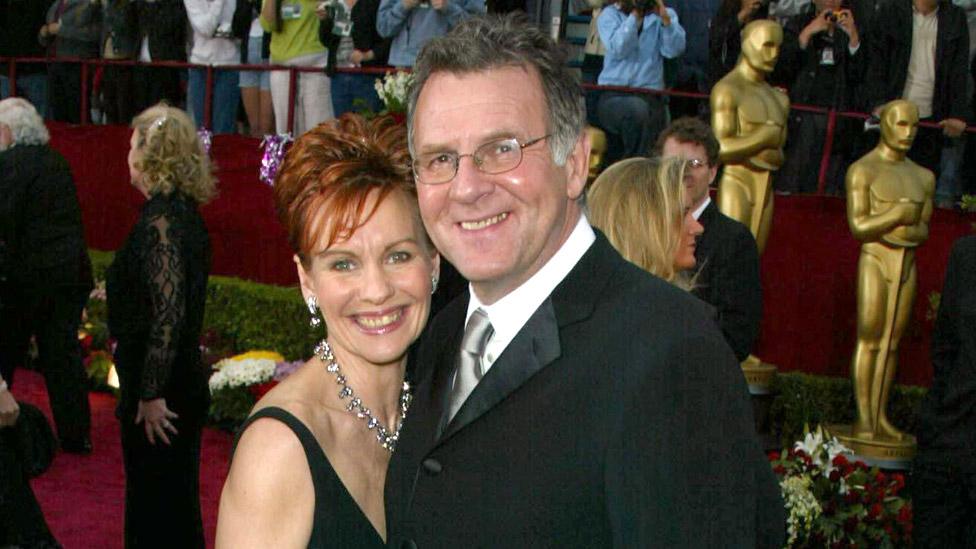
[298, 191, 440, 365]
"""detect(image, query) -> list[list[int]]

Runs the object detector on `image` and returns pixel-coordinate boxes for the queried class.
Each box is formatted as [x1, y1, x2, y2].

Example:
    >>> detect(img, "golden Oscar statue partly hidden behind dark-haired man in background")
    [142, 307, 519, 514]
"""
[710, 19, 790, 394]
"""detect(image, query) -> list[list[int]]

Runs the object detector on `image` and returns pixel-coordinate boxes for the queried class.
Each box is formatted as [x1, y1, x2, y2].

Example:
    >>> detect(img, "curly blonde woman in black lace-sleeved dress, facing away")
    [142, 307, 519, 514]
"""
[107, 105, 214, 548]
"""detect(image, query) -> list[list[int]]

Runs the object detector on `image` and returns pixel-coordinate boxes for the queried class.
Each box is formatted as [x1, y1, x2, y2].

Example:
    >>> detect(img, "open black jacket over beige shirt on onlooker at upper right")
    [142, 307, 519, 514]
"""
[866, 0, 969, 120]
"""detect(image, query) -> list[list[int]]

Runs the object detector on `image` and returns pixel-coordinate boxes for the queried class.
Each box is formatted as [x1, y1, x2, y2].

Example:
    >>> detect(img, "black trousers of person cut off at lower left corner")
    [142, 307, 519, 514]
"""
[0, 427, 60, 549]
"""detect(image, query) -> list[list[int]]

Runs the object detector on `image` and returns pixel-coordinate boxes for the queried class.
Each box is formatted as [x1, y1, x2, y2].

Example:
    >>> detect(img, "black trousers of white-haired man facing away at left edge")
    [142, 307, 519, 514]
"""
[0, 286, 91, 441]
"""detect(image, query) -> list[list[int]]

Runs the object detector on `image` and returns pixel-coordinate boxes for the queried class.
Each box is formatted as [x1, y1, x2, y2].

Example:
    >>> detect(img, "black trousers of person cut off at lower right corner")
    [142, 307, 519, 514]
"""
[912, 449, 976, 549]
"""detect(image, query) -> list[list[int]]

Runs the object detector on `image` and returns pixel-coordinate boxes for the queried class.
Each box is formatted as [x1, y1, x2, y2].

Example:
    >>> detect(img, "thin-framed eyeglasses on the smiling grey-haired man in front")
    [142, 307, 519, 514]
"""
[413, 135, 549, 185]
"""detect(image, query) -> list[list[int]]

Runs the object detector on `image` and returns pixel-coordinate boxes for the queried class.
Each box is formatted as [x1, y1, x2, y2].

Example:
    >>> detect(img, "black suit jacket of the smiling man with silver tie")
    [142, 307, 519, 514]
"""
[386, 233, 785, 548]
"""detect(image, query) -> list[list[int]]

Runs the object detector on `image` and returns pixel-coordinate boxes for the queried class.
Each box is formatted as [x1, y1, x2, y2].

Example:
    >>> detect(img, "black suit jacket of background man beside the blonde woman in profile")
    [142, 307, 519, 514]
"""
[692, 201, 762, 362]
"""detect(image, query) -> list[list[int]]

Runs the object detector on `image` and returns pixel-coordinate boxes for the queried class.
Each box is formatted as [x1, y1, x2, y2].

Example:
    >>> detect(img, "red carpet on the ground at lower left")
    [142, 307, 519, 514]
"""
[13, 370, 232, 549]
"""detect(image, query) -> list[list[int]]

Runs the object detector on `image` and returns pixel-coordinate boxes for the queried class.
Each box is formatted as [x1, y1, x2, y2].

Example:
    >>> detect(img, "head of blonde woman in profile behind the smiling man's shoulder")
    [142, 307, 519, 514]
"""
[587, 158, 704, 290]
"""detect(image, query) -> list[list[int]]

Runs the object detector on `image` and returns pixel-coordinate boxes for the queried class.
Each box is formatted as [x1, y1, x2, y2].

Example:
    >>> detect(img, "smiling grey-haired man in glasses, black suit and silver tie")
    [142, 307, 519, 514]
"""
[386, 17, 785, 548]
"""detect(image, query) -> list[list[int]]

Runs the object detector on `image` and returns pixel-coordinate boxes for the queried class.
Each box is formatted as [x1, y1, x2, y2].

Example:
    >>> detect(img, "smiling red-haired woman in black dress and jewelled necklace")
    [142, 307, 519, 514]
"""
[217, 115, 439, 548]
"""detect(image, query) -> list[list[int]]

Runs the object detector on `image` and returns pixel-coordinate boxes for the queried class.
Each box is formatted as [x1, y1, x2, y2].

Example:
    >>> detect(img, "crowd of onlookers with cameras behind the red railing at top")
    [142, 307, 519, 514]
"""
[0, 0, 976, 203]
